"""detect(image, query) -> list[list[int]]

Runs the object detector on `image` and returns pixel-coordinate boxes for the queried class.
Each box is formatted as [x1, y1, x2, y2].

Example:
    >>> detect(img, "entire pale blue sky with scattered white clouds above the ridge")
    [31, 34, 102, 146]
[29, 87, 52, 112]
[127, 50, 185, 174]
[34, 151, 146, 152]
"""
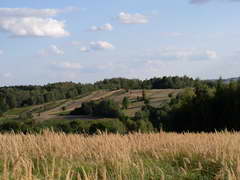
[0, 0, 240, 86]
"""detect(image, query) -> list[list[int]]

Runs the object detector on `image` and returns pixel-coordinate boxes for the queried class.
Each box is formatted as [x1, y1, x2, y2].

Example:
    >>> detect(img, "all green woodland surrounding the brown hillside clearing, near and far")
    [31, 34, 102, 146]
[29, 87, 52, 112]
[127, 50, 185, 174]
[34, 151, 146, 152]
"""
[0, 77, 240, 134]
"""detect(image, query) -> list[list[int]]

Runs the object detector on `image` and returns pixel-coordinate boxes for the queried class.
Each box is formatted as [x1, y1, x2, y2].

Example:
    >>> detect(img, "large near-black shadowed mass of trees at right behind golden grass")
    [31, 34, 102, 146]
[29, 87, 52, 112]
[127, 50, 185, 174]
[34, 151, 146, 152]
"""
[146, 80, 240, 132]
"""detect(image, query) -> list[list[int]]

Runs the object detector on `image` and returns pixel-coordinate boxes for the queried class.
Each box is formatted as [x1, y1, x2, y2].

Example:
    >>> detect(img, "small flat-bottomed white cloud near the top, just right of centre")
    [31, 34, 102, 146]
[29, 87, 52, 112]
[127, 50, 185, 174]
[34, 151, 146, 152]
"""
[117, 12, 148, 24]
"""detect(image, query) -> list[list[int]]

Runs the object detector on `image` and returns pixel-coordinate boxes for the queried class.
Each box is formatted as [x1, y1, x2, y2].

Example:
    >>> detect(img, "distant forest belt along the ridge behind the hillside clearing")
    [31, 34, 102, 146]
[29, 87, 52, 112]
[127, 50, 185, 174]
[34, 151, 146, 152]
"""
[0, 76, 210, 114]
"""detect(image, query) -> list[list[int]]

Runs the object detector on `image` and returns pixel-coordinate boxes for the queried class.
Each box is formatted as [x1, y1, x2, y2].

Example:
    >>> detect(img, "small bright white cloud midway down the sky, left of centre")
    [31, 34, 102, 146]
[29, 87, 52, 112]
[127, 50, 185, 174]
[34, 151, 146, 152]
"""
[80, 41, 114, 52]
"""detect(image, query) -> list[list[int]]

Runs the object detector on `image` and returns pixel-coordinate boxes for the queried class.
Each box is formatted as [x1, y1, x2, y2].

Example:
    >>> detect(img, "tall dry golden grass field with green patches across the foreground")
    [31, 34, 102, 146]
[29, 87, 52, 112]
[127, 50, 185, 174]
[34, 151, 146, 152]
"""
[0, 132, 240, 180]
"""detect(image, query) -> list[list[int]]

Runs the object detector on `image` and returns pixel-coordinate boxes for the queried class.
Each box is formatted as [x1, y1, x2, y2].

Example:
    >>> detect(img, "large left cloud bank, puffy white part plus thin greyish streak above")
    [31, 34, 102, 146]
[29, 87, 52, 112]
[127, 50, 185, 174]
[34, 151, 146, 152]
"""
[0, 8, 69, 38]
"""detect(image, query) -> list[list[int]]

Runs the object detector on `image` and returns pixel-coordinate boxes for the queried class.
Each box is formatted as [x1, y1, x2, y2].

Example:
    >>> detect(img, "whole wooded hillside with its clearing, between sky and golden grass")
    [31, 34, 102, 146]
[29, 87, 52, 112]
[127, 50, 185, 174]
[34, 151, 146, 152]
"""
[0, 76, 240, 134]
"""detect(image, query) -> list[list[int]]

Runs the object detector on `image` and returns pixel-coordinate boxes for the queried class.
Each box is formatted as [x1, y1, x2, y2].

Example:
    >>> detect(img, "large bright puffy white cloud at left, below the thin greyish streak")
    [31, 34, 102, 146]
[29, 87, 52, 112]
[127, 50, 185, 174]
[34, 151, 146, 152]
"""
[0, 17, 69, 38]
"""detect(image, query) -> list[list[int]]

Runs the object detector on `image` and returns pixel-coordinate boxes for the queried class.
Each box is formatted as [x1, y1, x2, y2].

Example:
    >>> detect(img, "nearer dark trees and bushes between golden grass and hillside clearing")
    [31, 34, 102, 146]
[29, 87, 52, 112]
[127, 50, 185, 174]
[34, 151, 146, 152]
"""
[0, 80, 240, 134]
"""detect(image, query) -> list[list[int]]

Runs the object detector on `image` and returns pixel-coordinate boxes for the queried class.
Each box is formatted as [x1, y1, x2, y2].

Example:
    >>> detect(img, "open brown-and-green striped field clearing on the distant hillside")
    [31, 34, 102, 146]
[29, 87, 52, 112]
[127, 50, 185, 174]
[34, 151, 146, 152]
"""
[5, 89, 181, 122]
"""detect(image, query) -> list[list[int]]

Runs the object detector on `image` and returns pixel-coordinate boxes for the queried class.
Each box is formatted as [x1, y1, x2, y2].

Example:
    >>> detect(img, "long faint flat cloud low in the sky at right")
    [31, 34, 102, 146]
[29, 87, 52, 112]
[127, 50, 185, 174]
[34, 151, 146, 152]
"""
[143, 48, 218, 61]
